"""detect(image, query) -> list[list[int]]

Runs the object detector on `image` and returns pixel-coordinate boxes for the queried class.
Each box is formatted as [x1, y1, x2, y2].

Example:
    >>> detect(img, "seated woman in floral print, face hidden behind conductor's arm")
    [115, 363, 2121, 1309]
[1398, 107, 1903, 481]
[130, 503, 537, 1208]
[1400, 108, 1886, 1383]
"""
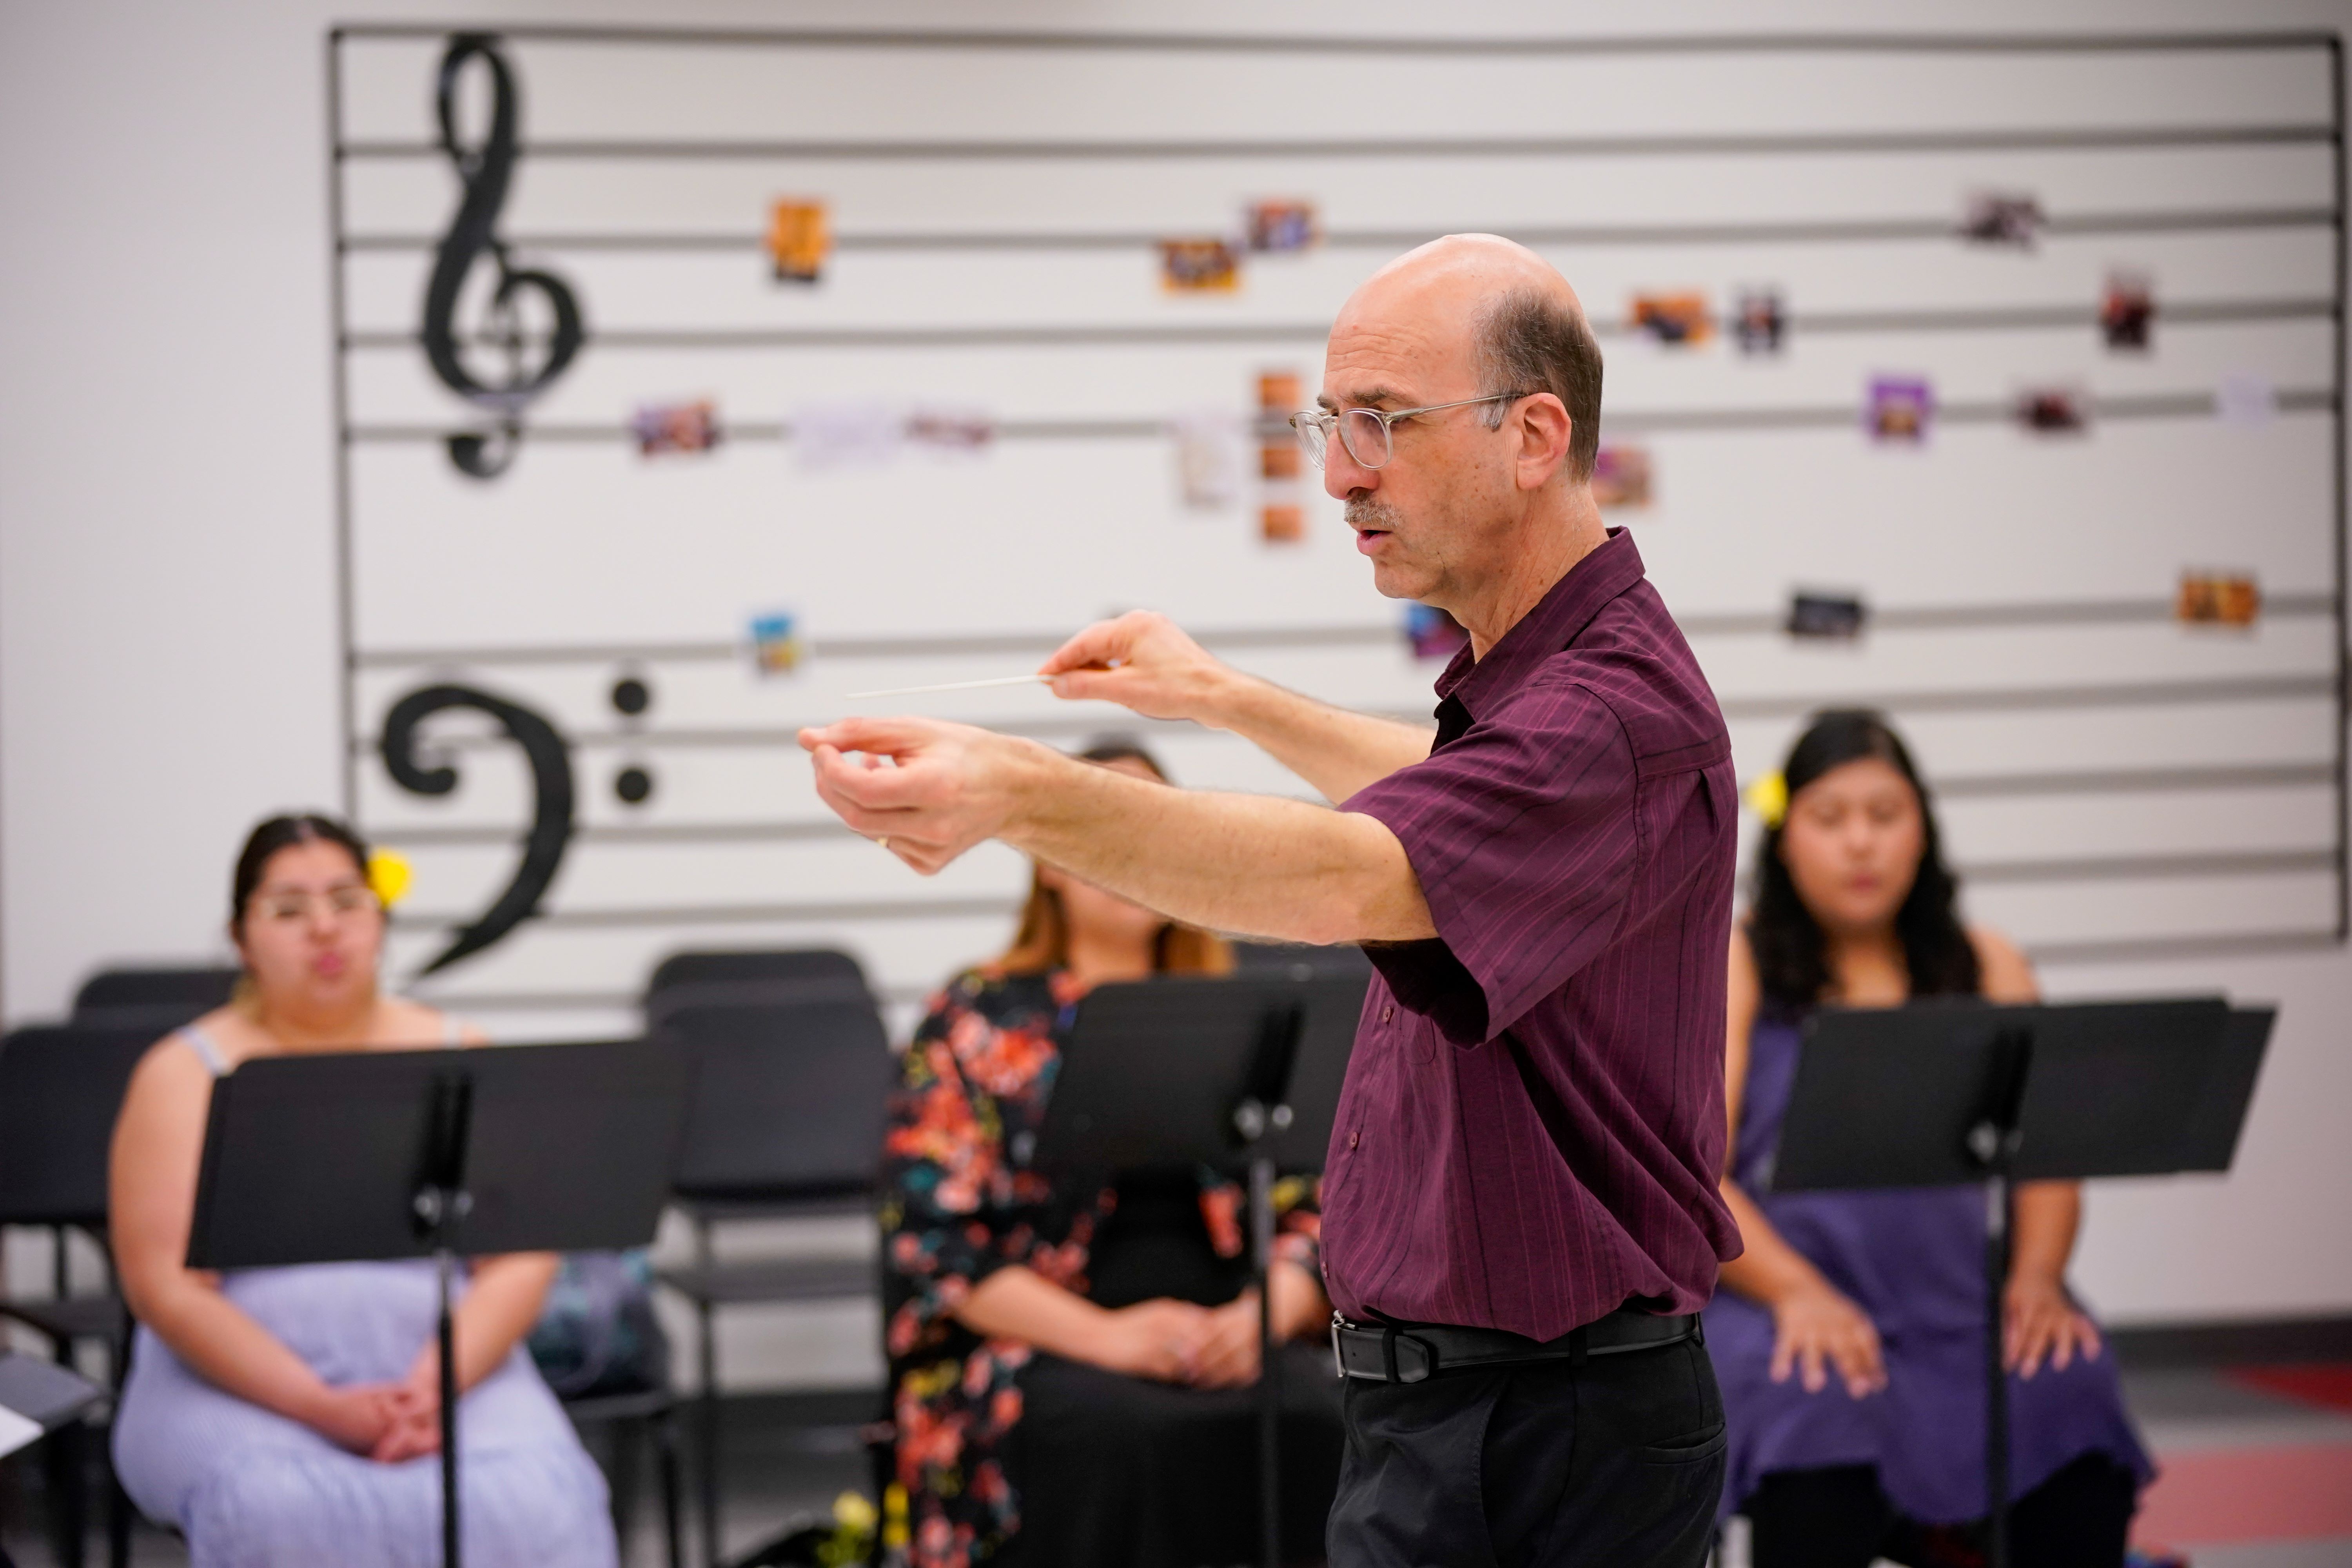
[882, 745, 1341, 1568]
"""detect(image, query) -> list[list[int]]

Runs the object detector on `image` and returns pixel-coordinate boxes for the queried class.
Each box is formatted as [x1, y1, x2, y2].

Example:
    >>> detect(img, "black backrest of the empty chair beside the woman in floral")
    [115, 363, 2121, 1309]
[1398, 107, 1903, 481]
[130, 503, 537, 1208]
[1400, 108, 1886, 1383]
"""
[668, 978, 894, 1201]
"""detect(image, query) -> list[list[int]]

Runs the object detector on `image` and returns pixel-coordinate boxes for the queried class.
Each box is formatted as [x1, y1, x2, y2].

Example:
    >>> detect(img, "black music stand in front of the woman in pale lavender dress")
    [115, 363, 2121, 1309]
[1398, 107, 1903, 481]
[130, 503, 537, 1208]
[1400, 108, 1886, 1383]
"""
[188, 1039, 687, 1568]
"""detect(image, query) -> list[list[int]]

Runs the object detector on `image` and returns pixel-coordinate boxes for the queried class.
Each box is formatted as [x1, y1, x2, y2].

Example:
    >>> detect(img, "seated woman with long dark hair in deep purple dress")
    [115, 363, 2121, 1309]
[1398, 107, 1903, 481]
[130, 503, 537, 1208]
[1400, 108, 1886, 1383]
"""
[1705, 712, 2152, 1568]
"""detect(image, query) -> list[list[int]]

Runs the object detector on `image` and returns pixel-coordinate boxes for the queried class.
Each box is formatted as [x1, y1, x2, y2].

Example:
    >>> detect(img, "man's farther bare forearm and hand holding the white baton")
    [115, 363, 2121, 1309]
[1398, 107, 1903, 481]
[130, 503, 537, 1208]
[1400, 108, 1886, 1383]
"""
[1040, 609, 1435, 802]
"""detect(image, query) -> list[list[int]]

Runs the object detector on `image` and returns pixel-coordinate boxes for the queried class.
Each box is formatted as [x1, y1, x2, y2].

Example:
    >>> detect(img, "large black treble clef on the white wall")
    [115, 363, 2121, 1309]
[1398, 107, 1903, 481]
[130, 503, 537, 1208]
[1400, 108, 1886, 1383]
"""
[423, 33, 583, 479]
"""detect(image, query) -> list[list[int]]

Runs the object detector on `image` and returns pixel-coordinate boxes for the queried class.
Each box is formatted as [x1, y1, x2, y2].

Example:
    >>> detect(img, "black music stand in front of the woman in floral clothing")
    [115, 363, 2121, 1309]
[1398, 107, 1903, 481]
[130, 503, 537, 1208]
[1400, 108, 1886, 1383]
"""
[1035, 973, 1367, 1568]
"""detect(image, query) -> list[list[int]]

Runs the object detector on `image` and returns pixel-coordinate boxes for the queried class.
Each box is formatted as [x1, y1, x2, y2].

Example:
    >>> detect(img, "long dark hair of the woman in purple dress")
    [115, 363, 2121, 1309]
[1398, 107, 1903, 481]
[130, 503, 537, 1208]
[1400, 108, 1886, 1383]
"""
[1748, 708, 1983, 1011]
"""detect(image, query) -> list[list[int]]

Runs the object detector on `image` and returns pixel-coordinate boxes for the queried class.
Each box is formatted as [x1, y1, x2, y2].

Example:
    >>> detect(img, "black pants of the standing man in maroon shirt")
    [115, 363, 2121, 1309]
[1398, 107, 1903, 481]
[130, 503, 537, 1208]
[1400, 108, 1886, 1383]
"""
[1329, 1345, 1724, 1568]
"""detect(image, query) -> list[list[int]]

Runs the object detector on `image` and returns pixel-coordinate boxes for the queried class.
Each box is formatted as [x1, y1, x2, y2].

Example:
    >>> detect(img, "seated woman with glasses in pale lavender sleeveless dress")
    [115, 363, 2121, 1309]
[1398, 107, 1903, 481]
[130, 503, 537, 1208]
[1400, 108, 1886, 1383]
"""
[111, 816, 616, 1568]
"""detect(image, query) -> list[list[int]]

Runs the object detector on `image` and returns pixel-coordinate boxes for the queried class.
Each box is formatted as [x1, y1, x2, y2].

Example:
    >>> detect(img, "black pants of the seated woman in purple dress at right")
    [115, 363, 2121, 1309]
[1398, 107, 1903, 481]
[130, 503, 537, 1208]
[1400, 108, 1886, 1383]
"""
[1740, 1453, 2138, 1568]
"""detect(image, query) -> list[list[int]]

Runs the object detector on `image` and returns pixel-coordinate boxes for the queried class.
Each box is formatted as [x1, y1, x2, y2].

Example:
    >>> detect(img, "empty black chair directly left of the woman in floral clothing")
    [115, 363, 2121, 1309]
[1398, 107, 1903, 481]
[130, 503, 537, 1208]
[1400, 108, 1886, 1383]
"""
[647, 952, 891, 1563]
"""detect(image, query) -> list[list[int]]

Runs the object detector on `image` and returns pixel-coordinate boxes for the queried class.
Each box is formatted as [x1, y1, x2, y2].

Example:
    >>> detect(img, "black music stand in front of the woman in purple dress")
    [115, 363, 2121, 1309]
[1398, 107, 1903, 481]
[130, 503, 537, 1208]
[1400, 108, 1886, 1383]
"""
[1766, 999, 2274, 1568]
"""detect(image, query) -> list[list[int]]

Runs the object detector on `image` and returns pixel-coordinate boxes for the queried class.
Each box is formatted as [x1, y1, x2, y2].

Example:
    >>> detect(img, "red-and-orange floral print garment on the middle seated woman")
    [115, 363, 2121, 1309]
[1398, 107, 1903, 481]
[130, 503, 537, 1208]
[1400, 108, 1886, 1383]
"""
[882, 971, 1319, 1568]
